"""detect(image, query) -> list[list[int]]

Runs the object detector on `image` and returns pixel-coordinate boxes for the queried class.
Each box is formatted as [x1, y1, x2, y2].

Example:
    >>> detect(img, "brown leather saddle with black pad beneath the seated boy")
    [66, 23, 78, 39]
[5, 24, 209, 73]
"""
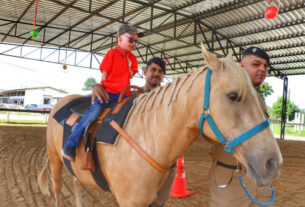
[53, 87, 144, 191]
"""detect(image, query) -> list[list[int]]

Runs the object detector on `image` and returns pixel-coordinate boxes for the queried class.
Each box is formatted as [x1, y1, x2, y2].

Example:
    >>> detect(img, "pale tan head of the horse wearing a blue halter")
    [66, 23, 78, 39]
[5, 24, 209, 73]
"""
[198, 43, 283, 185]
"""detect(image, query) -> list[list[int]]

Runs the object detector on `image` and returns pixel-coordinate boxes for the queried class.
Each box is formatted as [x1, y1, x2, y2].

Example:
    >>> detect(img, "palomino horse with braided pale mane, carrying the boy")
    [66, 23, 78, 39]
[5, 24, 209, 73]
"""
[39, 44, 282, 207]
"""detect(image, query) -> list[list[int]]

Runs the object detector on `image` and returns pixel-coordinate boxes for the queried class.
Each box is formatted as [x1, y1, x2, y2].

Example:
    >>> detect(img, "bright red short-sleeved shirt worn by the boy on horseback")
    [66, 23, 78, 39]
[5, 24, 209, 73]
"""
[100, 45, 138, 96]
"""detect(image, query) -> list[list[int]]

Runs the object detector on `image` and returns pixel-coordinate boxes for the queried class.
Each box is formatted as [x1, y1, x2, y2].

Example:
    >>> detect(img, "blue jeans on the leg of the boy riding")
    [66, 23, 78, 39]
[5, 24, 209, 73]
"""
[64, 93, 122, 148]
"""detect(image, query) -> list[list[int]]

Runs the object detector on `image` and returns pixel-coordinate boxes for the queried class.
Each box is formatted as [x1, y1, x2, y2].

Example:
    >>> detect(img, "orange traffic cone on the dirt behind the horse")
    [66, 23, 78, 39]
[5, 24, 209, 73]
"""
[170, 155, 194, 198]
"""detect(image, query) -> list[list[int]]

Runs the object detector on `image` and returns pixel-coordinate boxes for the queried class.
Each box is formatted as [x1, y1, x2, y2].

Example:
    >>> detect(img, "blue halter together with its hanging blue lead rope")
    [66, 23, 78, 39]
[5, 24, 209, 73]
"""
[199, 69, 275, 206]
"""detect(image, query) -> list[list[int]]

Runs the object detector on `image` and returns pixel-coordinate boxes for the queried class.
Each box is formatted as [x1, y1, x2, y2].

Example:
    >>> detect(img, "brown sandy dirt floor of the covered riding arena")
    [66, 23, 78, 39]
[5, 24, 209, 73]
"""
[0, 125, 305, 207]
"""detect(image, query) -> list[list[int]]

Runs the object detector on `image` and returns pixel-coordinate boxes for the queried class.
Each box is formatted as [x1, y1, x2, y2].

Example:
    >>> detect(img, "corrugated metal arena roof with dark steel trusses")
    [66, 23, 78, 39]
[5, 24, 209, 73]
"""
[0, 0, 305, 76]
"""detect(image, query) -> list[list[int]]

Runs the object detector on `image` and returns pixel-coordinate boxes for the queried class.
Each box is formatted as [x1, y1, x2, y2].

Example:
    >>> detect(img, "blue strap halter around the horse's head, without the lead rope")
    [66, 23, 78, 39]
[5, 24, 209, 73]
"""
[199, 69, 269, 154]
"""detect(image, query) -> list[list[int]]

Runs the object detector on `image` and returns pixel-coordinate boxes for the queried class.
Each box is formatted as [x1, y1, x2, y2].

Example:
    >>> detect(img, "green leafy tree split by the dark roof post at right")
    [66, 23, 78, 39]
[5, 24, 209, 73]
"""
[270, 96, 300, 120]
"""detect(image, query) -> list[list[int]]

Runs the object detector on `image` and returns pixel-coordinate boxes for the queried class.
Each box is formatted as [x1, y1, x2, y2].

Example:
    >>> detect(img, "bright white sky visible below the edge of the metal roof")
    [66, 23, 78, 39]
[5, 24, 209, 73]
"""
[0, 55, 305, 109]
